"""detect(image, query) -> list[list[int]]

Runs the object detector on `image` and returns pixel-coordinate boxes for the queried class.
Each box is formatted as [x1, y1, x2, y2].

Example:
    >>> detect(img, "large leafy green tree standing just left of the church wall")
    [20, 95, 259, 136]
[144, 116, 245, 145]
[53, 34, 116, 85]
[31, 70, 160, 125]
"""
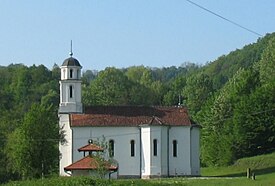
[6, 103, 59, 179]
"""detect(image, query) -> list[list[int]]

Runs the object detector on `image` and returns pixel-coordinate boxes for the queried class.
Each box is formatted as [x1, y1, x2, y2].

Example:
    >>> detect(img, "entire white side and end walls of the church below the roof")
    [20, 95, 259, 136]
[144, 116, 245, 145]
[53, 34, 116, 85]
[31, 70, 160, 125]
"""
[60, 123, 200, 178]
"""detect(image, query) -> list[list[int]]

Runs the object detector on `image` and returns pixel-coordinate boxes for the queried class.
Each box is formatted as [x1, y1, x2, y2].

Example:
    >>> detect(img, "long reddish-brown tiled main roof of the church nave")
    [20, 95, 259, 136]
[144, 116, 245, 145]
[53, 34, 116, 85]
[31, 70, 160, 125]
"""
[70, 106, 192, 127]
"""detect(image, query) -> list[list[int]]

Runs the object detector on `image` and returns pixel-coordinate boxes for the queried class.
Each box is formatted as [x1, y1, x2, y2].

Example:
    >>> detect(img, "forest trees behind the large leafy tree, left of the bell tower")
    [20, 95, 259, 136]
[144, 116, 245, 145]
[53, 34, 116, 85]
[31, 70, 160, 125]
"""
[0, 64, 60, 183]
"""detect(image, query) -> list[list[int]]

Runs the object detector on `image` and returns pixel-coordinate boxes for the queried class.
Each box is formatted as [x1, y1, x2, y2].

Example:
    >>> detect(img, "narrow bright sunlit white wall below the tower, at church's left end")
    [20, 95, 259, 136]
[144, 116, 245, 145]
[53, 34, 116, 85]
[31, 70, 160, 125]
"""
[59, 114, 72, 176]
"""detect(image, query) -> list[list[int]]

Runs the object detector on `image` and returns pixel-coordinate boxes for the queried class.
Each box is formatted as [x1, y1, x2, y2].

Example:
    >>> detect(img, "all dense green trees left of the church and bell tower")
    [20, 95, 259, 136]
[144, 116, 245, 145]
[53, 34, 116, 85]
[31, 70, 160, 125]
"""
[0, 64, 60, 183]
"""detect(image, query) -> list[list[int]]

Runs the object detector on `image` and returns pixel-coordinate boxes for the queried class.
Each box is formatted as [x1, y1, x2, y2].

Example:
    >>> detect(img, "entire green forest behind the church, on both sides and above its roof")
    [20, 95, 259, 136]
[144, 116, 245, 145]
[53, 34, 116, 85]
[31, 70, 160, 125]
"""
[0, 34, 275, 183]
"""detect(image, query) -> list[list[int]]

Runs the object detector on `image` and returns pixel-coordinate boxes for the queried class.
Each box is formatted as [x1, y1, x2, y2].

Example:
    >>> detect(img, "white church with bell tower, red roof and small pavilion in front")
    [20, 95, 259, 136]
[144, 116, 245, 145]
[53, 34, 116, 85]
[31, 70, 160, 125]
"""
[58, 54, 200, 178]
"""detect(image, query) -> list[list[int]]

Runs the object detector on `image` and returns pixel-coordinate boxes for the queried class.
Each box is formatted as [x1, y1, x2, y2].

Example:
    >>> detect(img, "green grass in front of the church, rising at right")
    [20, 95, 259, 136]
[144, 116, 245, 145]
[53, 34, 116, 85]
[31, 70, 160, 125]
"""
[4, 153, 275, 186]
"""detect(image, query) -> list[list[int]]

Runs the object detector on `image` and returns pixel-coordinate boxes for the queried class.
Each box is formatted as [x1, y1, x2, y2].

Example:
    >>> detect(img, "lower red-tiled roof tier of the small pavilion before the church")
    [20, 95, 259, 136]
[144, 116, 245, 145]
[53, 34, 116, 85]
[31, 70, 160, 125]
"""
[64, 156, 117, 171]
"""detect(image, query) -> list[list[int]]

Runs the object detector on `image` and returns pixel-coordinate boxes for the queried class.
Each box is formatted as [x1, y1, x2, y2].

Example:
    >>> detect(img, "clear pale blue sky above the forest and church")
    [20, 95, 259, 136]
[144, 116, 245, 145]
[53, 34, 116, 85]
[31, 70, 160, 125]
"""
[0, 0, 275, 70]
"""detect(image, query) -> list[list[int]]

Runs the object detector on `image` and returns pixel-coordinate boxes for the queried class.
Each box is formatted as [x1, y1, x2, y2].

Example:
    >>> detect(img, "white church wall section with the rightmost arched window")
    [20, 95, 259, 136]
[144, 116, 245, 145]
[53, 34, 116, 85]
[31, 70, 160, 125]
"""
[169, 126, 191, 176]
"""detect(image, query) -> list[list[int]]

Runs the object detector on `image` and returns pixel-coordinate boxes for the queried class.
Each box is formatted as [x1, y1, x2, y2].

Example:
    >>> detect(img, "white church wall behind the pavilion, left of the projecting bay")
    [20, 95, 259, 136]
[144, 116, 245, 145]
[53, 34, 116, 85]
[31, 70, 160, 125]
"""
[72, 127, 140, 176]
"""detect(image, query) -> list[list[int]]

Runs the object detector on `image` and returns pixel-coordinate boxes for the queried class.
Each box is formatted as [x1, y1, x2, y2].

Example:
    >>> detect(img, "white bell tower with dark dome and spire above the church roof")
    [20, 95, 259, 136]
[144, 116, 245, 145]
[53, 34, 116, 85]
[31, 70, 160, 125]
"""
[59, 43, 82, 114]
